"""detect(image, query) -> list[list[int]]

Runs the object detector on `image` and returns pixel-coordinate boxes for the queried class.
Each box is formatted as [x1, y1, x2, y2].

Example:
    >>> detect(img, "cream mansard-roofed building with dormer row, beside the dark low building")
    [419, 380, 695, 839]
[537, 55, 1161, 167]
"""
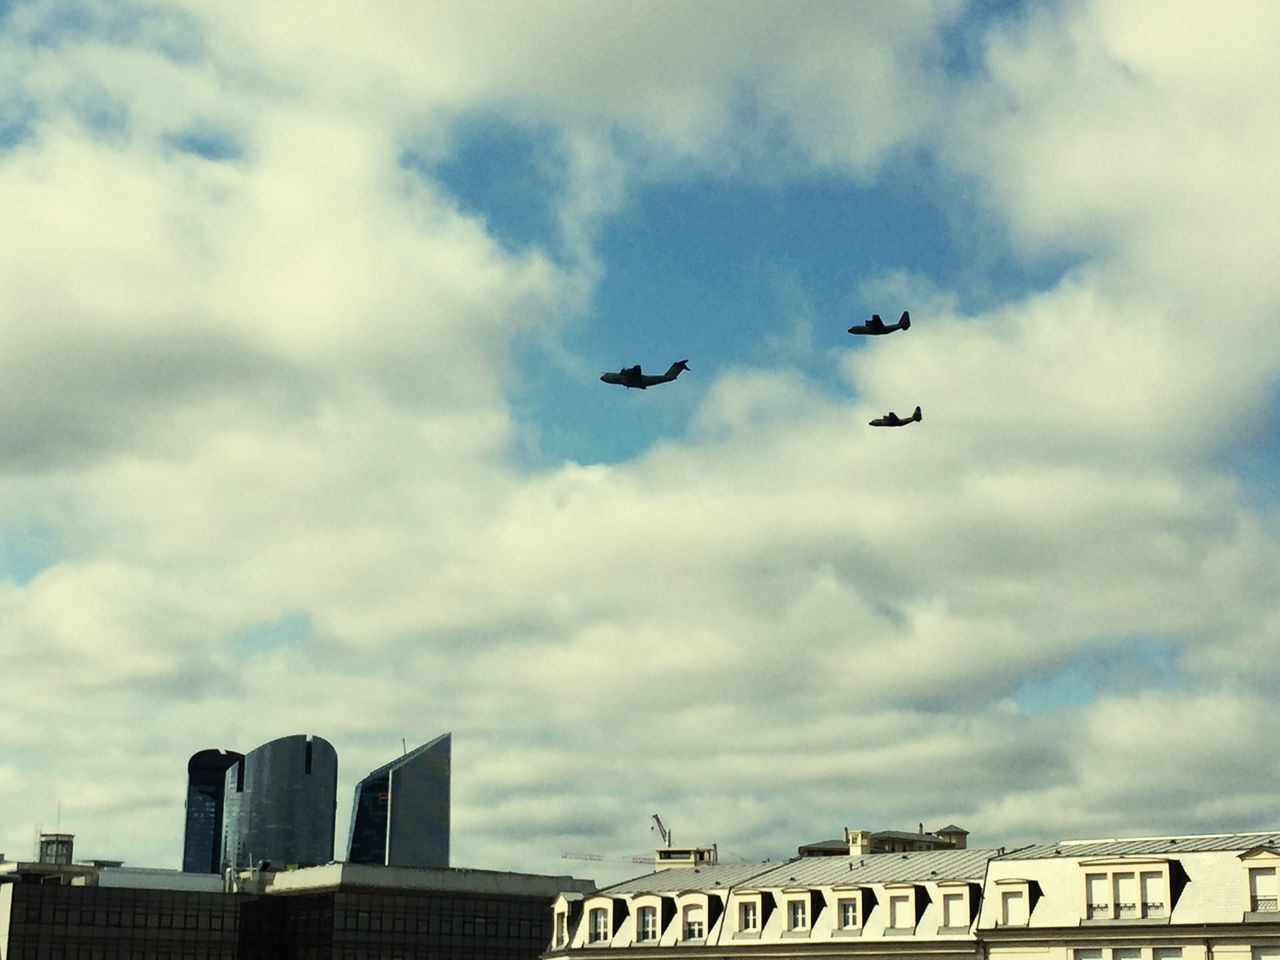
[548, 849, 997, 960]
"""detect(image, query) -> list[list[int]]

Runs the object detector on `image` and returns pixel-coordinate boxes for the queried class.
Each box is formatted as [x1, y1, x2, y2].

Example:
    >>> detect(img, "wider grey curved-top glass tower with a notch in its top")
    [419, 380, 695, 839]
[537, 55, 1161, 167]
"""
[219, 733, 338, 870]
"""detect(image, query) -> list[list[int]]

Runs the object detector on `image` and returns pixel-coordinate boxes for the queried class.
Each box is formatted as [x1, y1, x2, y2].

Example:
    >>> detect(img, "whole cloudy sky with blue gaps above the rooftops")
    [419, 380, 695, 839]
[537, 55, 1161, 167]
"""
[0, 0, 1280, 882]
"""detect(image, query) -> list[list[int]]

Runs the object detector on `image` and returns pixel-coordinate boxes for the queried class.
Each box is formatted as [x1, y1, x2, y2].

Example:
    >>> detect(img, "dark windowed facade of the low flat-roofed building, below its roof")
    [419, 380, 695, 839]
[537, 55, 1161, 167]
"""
[0, 877, 586, 960]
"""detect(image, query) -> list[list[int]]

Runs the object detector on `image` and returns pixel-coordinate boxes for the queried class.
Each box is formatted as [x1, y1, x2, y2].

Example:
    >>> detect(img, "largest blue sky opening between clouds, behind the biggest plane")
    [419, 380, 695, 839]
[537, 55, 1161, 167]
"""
[517, 157, 1073, 463]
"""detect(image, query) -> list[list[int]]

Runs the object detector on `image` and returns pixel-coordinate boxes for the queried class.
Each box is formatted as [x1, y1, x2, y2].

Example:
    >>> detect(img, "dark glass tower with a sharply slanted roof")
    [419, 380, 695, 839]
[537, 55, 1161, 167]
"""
[347, 733, 452, 868]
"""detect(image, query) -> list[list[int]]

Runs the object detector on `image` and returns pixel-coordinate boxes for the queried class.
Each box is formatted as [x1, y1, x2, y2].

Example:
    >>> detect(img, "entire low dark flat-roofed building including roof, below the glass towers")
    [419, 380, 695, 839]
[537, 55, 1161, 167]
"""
[0, 863, 595, 960]
